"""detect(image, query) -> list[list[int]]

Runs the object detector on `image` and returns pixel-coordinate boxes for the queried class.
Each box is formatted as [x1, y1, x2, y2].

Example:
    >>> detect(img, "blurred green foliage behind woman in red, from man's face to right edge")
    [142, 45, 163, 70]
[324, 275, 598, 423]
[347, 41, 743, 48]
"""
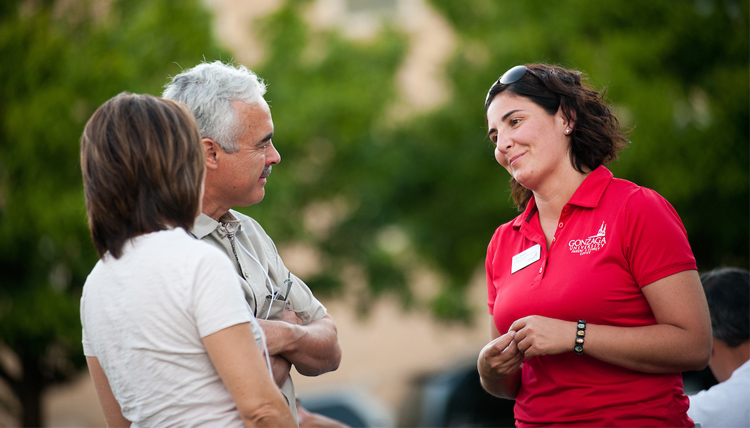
[247, 0, 750, 320]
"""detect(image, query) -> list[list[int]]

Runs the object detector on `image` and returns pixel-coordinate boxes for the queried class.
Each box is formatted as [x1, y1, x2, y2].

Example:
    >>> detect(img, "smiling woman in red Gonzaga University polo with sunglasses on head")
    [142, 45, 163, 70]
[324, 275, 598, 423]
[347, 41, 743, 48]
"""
[477, 64, 711, 426]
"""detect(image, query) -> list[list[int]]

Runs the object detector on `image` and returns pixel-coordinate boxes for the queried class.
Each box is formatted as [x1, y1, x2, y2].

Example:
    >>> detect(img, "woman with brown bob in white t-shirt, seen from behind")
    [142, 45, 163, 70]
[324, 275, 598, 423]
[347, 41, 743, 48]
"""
[81, 93, 296, 427]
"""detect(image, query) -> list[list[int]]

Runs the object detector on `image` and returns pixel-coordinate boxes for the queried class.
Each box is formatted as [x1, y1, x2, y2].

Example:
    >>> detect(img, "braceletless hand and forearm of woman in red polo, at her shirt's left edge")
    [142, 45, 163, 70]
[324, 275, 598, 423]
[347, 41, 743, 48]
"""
[477, 315, 523, 399]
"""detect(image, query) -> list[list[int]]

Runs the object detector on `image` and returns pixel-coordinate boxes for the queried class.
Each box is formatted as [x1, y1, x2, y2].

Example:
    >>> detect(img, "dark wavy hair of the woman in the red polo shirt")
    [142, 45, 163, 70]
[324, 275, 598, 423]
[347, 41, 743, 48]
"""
[484, 64, 629, 211]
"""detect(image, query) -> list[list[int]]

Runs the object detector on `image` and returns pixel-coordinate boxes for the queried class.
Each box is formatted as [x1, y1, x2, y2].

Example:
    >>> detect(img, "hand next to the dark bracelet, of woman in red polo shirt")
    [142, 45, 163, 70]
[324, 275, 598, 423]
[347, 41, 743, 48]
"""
[508, 315, 576, 358]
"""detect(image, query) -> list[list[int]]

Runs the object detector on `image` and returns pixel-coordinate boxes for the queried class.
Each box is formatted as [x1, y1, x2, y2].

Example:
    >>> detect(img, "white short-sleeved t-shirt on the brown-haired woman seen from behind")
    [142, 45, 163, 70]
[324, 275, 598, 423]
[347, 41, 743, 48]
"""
[81, 228, 262, 427]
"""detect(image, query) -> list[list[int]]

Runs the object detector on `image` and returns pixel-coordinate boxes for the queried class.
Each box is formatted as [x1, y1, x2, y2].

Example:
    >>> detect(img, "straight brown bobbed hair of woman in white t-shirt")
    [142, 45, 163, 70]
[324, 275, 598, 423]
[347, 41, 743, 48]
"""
[81, 92, 205, 258]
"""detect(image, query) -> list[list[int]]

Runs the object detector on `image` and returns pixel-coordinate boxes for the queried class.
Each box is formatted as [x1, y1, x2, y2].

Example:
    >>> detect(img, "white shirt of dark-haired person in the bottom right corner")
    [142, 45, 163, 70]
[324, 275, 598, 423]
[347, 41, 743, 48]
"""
[688, 361, 750, 428]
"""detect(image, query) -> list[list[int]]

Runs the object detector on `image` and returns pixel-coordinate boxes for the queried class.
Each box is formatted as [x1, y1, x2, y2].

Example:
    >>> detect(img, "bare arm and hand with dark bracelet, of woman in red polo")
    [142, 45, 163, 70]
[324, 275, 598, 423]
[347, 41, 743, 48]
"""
[511, 270, 711, 373]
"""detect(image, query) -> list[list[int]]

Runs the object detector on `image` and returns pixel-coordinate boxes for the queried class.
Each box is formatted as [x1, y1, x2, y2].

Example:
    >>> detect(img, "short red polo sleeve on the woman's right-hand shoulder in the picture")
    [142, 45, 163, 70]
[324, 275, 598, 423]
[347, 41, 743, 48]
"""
[625, 187, 697, 287]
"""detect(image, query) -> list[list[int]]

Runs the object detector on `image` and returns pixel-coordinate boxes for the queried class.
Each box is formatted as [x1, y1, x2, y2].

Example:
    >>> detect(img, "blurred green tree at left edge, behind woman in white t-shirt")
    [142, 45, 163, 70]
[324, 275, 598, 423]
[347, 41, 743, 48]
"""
[0, 0, 226, 426]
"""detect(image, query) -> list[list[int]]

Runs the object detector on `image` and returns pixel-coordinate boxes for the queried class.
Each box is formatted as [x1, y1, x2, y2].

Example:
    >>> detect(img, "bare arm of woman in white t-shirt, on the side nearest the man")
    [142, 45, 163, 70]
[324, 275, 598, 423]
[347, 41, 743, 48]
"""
[203, 323, 297, 427]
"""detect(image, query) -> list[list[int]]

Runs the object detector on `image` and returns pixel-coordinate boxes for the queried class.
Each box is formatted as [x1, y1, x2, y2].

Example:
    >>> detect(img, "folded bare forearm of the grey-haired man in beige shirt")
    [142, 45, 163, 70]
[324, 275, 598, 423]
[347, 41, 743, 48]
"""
[258, 310, 341, 376]
